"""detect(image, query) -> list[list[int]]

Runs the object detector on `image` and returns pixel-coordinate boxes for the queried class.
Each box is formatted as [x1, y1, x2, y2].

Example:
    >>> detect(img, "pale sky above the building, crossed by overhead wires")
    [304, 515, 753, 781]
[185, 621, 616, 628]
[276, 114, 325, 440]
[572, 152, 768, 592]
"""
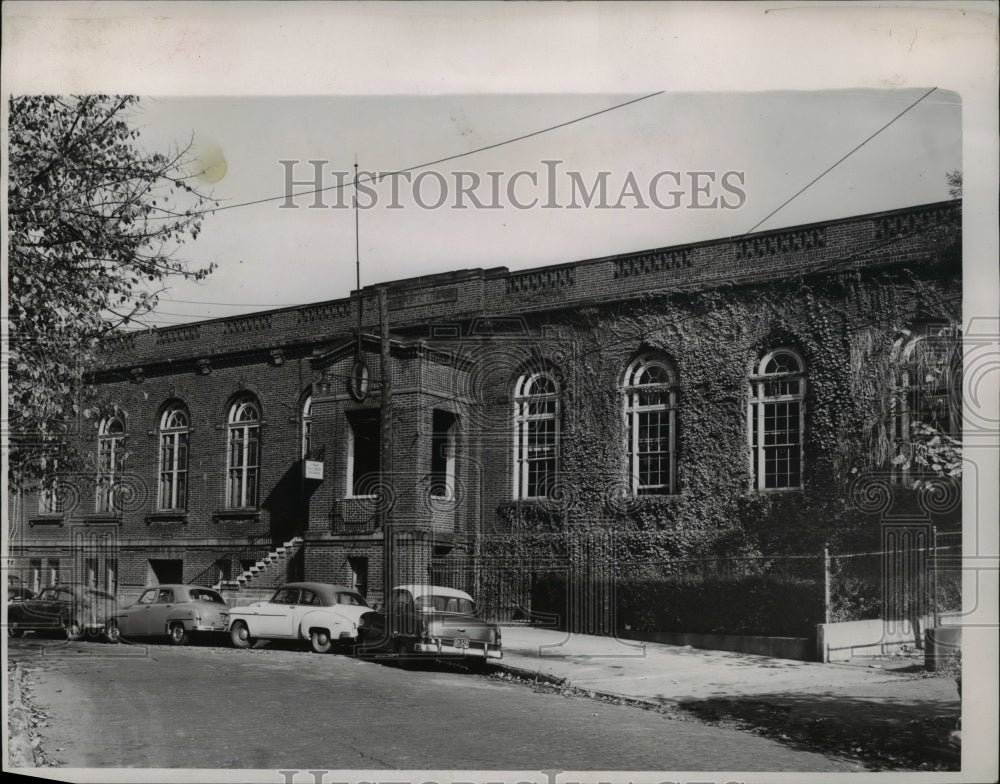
[133, 87, 962, 326]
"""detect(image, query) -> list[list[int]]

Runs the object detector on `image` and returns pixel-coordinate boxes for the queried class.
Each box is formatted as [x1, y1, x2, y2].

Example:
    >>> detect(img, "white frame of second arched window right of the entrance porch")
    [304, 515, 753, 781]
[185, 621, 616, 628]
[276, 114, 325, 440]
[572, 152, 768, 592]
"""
[622, 352, 677, 496]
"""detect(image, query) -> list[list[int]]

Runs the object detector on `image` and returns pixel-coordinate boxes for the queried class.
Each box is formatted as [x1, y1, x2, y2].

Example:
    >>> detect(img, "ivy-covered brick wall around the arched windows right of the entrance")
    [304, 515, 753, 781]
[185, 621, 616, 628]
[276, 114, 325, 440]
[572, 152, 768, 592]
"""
[477, 250, 961, 562]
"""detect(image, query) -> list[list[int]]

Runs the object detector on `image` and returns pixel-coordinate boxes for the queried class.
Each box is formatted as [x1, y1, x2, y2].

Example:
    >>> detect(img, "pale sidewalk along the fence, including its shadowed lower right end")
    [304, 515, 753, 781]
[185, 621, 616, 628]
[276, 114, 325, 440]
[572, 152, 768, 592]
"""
[500, 626, 961, 769]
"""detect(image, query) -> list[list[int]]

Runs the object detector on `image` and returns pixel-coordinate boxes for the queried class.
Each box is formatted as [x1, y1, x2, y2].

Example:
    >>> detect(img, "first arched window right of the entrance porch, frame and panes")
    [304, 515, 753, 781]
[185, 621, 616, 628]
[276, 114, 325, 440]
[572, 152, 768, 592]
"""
[514, 373, 559, 498]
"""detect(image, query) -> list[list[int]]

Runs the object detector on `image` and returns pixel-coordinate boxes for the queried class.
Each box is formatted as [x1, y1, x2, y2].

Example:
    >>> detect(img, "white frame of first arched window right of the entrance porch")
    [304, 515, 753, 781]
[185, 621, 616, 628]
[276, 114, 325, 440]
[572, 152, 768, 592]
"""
[513, 372, 562, 500]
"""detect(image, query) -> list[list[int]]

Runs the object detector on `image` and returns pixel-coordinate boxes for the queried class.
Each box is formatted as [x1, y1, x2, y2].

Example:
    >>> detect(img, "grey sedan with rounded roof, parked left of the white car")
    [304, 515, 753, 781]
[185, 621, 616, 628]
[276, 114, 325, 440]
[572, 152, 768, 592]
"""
[105, 585, 229, 645]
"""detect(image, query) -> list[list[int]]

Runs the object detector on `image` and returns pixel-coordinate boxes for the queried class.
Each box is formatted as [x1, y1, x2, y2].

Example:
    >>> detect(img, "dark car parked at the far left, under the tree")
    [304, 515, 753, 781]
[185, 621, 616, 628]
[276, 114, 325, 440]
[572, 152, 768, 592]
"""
[7, 585, 118, 640]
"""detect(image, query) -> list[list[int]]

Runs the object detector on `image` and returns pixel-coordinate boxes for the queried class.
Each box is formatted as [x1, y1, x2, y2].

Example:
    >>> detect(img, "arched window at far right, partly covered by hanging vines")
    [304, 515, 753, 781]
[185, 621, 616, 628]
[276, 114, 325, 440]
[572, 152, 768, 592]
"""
[892, 325, 962, 485]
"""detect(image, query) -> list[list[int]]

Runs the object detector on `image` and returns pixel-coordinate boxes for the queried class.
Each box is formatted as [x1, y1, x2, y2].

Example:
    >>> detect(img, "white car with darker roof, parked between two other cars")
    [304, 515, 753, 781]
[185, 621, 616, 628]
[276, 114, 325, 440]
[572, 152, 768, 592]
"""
[229, 582, 372, 653]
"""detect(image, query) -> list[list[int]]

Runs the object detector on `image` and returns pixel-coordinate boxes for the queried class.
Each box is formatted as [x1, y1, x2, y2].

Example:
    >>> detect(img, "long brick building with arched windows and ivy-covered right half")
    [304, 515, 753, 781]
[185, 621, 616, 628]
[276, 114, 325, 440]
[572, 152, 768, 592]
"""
[10, 202, 961, 600]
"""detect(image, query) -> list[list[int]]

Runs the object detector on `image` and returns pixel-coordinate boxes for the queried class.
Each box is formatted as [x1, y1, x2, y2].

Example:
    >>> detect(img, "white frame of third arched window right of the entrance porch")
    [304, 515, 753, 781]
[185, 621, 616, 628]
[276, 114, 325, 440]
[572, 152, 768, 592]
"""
[747, 347, 806, 492]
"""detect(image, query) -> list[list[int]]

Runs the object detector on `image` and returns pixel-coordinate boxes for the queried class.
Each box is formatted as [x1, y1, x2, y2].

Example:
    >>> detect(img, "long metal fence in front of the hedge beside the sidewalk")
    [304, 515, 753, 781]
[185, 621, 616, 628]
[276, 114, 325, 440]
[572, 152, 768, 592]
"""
[428, 527, 961, 636]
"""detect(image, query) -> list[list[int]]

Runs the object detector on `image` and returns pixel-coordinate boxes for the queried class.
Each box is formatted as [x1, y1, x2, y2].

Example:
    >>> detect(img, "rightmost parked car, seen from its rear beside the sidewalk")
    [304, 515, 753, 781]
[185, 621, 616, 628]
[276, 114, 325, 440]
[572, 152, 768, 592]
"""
[366, 585, 503, 662]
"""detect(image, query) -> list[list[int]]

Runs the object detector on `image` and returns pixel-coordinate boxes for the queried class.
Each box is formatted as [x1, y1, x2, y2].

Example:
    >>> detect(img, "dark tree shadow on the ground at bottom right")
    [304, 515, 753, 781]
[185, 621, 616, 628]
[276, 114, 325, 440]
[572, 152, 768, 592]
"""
[677, 693, 961, 771]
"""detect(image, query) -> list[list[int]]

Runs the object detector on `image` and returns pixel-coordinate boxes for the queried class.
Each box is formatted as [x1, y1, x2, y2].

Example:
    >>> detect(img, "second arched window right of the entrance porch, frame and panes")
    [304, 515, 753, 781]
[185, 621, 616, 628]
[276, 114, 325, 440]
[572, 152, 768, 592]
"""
[622, 353, 677, 495]
